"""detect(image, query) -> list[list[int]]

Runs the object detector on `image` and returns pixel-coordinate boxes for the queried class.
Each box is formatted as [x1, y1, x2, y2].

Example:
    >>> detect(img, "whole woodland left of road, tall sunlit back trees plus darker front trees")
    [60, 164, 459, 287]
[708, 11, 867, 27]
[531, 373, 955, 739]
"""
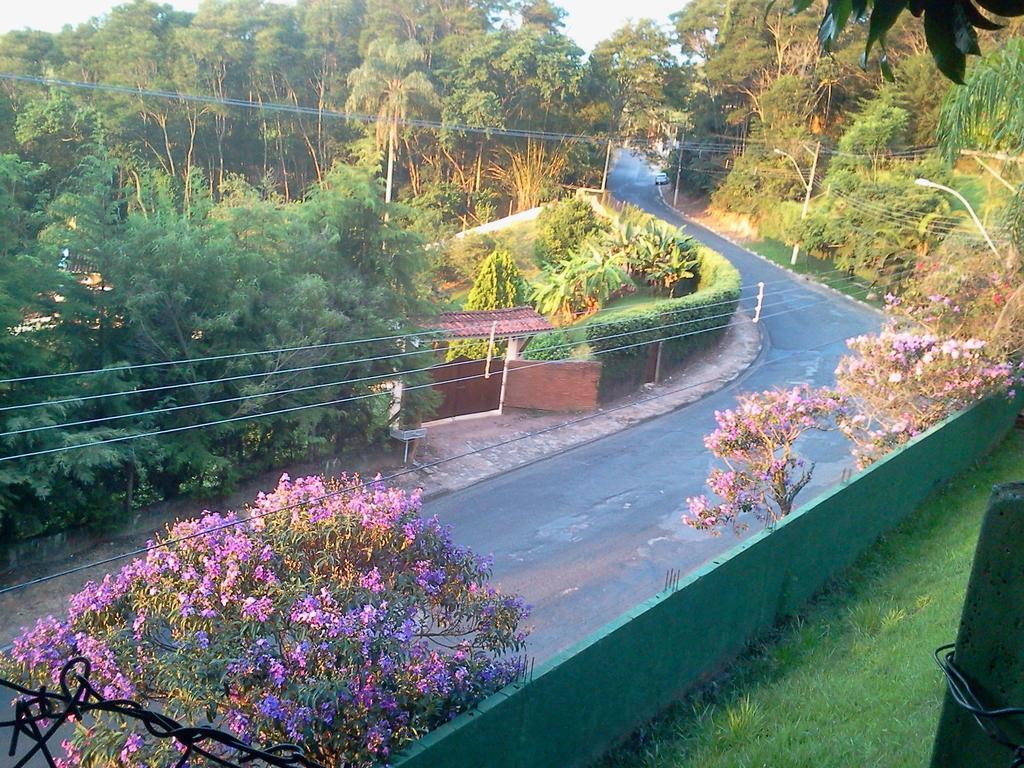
[0, 0, 696, 541]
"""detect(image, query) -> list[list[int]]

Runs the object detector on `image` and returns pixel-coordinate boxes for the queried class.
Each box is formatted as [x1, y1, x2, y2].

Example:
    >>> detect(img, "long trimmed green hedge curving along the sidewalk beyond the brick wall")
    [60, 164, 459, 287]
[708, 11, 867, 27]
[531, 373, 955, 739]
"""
[586, 246, 739, 393]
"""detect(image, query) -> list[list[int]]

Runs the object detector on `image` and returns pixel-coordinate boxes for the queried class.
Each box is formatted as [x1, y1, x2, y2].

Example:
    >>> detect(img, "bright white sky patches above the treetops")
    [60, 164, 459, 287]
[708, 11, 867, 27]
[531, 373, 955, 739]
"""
[0, 0, 685, 51]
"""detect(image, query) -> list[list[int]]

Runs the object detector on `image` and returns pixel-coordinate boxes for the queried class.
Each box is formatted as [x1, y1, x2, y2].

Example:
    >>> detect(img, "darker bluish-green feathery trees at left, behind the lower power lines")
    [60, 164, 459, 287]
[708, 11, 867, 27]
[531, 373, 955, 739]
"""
[0, 155, 436, 538]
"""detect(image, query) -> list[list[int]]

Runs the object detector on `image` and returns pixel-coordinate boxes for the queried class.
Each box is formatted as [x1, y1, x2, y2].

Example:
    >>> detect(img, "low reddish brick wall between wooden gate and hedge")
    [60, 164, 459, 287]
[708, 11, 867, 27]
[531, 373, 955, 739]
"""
[505, 360, 601, 412]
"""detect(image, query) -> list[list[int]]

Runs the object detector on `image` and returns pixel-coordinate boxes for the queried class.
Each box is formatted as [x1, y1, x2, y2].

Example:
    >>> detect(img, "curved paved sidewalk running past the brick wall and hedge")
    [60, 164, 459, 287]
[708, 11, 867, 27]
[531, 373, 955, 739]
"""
[398, 311, 761, 498]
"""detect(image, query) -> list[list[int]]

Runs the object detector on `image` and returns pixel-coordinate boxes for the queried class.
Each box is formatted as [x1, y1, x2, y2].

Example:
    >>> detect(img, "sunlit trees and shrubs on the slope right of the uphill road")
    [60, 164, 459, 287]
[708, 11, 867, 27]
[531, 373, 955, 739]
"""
[670, 0, 1024, 295]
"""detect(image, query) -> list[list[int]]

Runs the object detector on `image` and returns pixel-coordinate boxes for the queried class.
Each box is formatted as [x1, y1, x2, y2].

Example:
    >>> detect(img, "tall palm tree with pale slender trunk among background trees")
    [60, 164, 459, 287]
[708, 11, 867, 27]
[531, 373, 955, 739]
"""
[346, 40, 437, 203]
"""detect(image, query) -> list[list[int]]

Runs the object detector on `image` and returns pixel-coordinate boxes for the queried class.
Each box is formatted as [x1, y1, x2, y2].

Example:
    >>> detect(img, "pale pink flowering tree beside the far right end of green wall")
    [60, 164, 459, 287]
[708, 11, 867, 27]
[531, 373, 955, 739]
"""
[836, 326, 1017, 467]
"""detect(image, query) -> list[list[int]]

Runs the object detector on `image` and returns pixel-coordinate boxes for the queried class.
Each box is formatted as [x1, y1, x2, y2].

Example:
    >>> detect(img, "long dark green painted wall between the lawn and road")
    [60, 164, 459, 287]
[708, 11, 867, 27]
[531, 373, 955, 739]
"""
[395, 398, 1024, 768]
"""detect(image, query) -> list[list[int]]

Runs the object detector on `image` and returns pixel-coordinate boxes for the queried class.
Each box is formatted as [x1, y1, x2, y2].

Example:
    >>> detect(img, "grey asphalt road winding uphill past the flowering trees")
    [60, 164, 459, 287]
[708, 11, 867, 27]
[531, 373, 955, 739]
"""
[425, 153, 881, 662]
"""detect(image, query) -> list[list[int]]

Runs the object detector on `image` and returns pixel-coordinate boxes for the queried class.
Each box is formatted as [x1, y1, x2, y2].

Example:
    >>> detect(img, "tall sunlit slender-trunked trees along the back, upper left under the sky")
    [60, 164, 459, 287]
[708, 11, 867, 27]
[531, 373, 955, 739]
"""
[0, 0, 678, 222]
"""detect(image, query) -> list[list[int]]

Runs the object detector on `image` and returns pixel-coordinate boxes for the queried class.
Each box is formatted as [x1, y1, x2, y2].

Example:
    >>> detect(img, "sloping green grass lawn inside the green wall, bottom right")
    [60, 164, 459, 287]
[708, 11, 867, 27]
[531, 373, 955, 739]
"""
[602, 431, 1024, 768]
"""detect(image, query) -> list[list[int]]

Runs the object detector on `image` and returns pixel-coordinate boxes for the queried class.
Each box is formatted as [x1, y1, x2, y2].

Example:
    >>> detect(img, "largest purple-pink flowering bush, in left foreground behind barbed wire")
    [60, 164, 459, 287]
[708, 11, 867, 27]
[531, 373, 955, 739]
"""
[4, 476, 526, 768]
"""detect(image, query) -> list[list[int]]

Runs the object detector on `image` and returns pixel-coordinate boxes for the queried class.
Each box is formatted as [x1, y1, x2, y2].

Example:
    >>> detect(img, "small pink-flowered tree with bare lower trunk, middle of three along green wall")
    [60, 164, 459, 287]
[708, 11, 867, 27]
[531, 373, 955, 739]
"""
[683, 385, 840, 534]
